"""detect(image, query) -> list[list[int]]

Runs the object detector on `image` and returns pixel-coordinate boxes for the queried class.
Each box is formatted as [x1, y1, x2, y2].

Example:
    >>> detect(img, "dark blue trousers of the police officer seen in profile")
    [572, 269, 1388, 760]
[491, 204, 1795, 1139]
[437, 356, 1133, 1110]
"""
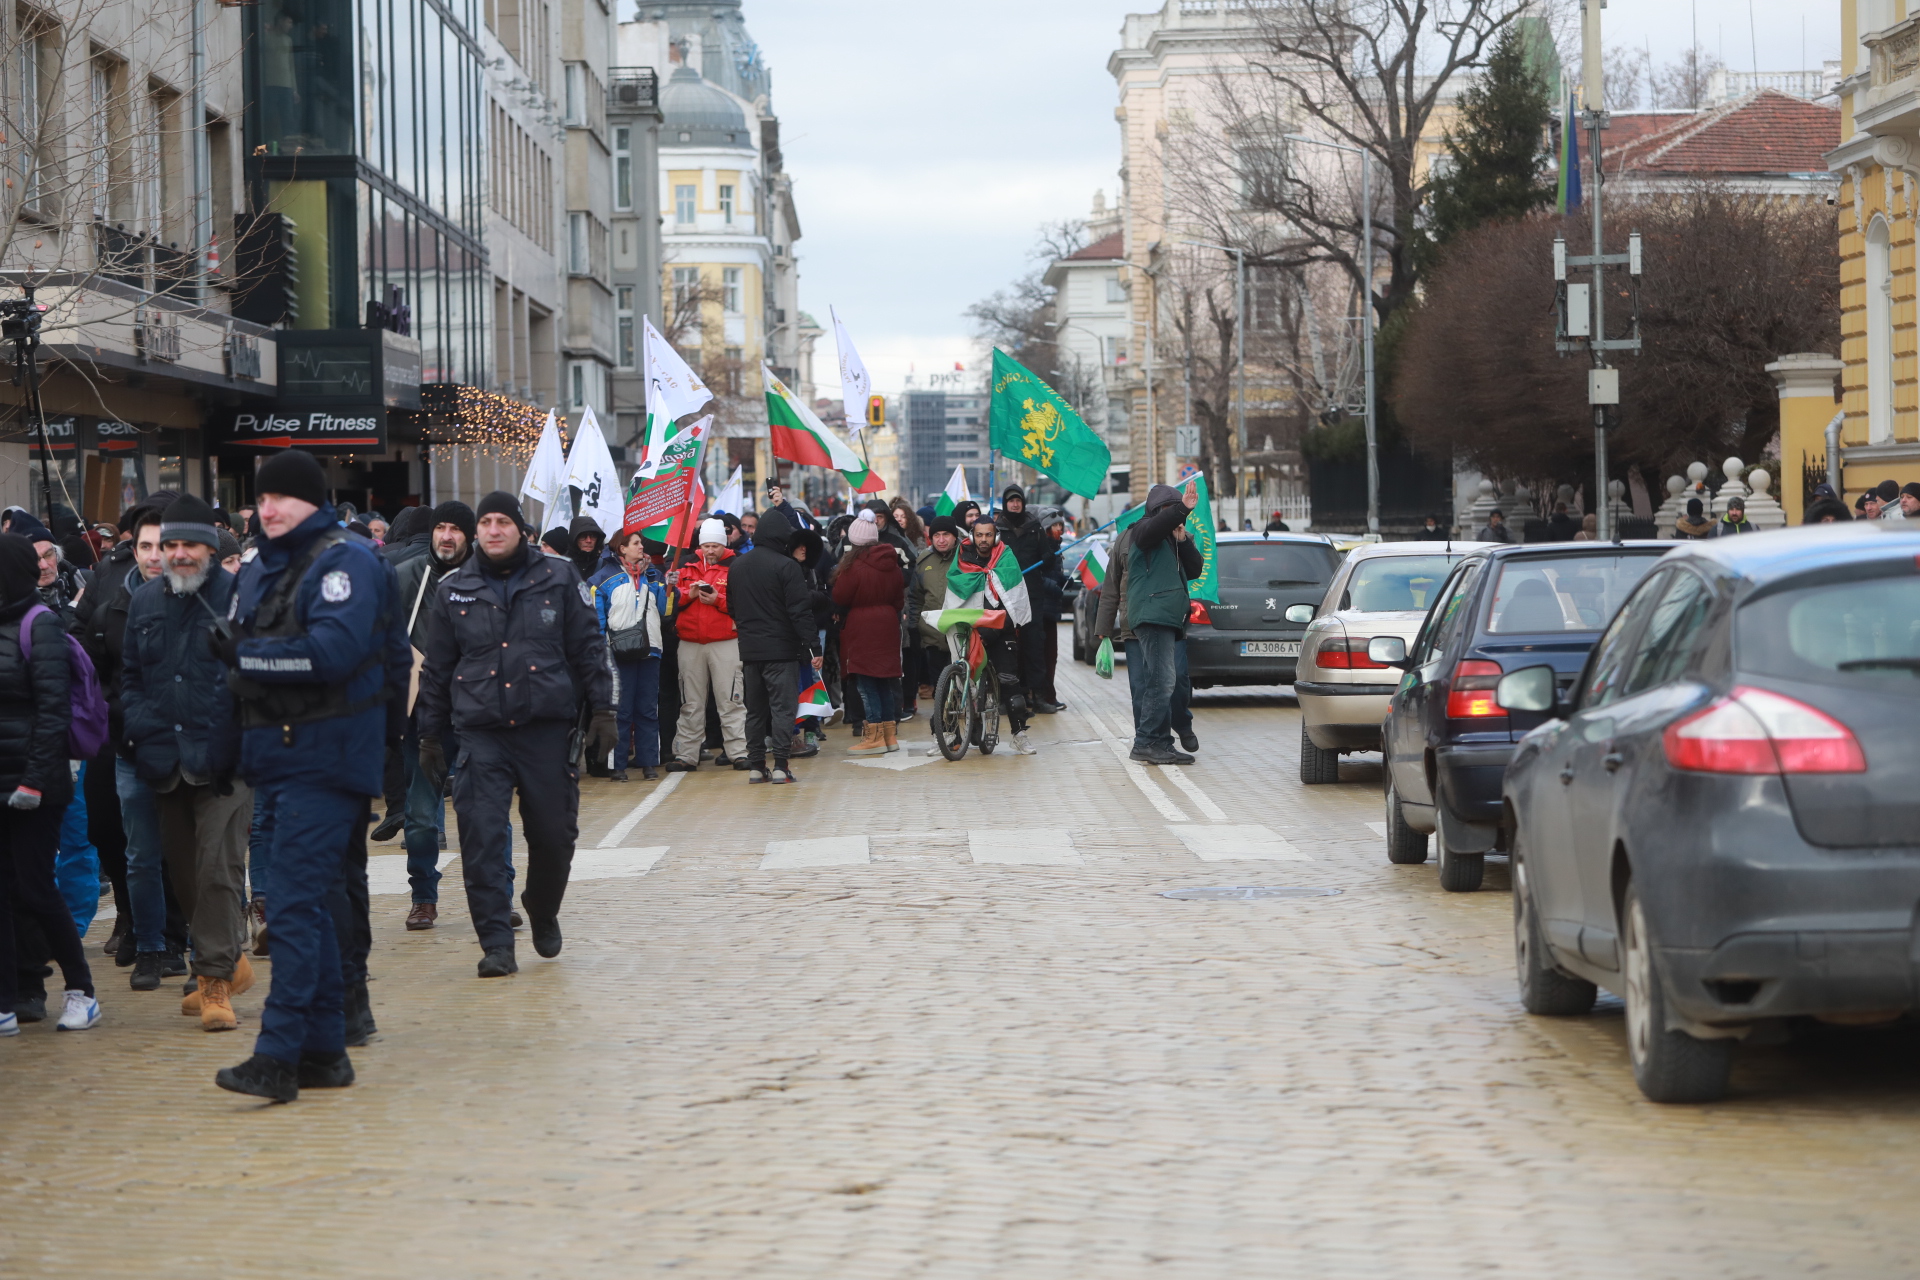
[253, 783, 367, 1063]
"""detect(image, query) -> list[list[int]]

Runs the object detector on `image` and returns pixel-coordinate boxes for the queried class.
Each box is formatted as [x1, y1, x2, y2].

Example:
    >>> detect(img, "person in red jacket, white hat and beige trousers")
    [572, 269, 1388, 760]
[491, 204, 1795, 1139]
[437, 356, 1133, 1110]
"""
[666, 516, 747, 773]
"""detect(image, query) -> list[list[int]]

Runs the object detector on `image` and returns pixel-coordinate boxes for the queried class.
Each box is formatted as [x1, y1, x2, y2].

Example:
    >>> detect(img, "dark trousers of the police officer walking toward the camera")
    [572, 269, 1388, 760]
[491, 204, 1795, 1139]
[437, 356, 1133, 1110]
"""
[453, 720, 580, 950]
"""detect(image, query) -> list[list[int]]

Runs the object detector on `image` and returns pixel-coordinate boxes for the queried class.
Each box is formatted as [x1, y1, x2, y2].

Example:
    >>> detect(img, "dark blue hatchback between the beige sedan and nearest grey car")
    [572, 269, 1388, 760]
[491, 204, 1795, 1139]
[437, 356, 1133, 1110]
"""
[1367, 543, 1672, 892]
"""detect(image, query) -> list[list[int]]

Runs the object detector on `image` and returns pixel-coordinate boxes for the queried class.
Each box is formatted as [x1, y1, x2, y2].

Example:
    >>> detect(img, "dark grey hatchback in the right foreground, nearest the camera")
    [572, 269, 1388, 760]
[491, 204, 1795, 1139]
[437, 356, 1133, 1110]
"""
[1496, 520, 1920, 1102]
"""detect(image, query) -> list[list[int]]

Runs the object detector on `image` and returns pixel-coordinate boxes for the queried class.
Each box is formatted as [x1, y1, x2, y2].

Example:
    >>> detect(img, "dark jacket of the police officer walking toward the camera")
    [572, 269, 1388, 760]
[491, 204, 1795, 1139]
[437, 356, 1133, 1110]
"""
[407, 543, 610, 737]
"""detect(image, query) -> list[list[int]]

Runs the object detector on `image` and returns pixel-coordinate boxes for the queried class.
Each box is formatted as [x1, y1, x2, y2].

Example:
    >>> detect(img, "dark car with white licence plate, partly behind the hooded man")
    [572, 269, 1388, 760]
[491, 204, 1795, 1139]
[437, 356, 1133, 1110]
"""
[1073, 533, 1340, 689]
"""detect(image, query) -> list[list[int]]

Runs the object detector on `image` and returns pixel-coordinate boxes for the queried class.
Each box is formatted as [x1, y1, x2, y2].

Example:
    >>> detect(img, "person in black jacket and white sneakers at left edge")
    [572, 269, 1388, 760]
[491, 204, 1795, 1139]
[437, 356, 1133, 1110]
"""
[0, 533, 100, 1034]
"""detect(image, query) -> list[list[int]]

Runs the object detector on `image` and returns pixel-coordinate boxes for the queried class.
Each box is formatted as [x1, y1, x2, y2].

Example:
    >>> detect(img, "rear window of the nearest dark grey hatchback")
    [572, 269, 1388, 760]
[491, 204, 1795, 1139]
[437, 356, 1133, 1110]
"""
[1734, 562, 1920, 693]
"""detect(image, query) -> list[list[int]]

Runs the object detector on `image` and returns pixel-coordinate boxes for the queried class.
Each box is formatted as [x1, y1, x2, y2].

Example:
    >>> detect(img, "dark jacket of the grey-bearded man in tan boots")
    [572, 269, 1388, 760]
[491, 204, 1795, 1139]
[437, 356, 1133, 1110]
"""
[119, 564, 240, 783]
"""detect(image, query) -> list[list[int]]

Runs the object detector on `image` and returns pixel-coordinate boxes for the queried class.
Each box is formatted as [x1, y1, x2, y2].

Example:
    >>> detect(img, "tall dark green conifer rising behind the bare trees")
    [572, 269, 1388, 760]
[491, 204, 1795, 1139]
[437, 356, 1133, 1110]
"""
[1421, 27, 1553, 265]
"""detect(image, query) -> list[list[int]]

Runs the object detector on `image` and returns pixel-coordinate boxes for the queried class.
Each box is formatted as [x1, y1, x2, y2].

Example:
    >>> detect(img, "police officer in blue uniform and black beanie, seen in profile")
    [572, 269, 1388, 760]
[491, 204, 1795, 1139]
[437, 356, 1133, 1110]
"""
[213, 449, 411, 1102]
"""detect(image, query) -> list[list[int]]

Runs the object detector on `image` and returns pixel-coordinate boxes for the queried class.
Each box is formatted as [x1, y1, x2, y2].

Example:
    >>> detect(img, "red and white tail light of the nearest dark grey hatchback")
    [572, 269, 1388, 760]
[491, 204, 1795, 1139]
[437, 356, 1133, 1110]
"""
[1661, 685, 1866, 773]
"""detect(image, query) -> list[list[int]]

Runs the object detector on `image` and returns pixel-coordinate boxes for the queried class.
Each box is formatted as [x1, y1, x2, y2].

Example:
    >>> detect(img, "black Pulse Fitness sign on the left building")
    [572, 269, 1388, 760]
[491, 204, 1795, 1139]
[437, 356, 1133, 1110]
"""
[223, 328, 420, 453]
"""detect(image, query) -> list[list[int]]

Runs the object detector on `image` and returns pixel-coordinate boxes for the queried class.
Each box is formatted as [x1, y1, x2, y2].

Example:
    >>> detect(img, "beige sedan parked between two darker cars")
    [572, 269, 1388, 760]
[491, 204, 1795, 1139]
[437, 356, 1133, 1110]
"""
[1288, 541, 1490, 785]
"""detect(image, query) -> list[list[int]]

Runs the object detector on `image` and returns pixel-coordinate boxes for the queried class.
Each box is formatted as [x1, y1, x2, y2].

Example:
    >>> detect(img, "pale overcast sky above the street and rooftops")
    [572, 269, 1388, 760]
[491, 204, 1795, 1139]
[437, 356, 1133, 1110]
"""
[745, 0, 1839, 395]
